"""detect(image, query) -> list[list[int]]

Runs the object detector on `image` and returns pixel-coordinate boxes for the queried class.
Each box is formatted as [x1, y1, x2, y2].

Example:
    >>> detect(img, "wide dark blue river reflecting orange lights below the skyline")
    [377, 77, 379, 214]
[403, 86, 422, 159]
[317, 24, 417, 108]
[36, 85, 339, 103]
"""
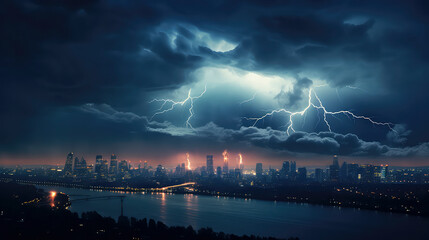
[39, 186, 429, 240]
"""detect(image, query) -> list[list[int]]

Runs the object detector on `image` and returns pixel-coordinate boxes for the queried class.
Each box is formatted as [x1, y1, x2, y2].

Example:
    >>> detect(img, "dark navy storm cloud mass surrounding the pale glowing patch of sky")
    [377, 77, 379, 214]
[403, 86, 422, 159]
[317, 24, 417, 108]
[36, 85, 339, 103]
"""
[0, 0, 429, 161]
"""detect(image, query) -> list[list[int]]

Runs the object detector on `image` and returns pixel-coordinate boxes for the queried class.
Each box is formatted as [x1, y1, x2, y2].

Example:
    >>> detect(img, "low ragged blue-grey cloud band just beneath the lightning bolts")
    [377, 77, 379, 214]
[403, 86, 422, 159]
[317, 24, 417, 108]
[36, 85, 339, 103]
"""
[80, 104, 429, 157]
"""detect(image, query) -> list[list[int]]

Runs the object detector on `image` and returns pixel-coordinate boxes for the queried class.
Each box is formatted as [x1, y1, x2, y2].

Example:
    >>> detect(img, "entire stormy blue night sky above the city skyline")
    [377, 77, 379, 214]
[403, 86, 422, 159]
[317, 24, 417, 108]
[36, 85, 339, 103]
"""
[0, 0, 429, 166]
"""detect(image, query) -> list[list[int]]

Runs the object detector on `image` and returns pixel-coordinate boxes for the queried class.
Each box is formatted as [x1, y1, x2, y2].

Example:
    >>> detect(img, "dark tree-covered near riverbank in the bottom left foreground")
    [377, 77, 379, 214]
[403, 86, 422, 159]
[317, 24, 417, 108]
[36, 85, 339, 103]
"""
[0, 183, 297, 240]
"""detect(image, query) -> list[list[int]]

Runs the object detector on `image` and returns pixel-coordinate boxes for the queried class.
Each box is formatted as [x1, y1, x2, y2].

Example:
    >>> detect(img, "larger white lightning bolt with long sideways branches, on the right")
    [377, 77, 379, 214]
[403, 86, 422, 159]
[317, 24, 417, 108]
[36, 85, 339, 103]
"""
[245, 88, 396, 135]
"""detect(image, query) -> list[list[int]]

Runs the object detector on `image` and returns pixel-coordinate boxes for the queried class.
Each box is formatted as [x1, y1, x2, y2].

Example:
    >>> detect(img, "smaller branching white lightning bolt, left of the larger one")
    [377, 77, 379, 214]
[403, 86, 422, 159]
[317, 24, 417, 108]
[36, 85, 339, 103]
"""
[149, 85, 207, 129]
